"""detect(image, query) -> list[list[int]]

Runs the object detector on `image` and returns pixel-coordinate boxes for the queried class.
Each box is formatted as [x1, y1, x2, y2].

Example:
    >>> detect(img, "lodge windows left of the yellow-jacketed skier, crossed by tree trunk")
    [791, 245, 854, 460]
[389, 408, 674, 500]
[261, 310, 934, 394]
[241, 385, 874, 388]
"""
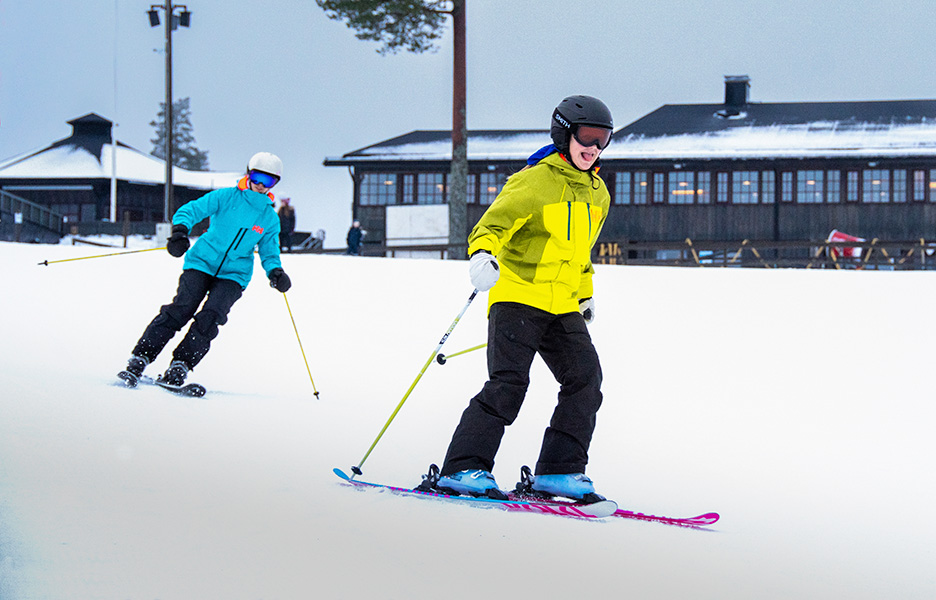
[360, 172, 507, 206]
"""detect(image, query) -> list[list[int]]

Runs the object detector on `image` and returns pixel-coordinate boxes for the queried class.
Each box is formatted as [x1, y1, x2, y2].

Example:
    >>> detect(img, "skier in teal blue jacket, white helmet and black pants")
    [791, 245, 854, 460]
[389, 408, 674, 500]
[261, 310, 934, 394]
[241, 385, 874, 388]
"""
[117, 152, 291, 387]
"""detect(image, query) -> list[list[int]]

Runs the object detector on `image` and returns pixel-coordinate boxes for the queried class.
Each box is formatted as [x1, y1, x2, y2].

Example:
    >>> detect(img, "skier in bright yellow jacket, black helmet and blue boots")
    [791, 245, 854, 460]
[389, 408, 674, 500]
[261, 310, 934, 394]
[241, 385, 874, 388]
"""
[435, 96, 613, 502]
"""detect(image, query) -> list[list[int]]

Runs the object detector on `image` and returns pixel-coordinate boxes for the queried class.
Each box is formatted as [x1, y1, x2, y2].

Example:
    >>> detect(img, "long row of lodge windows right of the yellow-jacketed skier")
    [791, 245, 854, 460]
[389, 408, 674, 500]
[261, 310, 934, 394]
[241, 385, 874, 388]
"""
[614, 169, 936, 204]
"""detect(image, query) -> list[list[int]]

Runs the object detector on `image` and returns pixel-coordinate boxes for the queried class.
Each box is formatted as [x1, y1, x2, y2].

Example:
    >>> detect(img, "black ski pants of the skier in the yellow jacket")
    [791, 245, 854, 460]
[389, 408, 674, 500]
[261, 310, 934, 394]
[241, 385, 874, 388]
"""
[441, 302, 602, 475]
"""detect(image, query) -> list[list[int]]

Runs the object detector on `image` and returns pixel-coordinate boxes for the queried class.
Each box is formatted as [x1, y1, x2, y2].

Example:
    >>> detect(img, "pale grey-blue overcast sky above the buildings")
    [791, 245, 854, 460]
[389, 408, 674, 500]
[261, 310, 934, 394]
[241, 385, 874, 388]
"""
[0, 0, 936, 241]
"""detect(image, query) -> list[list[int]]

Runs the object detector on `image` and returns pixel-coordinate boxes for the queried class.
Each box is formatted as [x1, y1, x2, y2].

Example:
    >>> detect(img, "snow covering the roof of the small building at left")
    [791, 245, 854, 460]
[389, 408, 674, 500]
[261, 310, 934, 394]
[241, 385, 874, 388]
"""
[0, 142, 243, 190]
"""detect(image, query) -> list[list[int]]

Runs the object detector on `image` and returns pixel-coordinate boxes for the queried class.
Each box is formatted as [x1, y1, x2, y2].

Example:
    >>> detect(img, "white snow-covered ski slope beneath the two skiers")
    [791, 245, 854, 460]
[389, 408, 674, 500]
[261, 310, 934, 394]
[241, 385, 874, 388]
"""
[0, 243, 936, 600]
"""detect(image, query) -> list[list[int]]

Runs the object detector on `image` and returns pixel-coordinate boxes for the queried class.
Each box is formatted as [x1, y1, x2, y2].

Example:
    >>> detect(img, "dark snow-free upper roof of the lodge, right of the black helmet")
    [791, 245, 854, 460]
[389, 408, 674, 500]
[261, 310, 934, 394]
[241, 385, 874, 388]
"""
[614, 100, 936, 140]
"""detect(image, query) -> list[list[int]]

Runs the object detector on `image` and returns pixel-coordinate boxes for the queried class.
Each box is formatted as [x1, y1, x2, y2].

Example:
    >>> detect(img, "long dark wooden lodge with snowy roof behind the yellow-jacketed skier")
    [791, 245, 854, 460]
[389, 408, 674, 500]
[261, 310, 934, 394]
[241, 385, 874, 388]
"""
[324, 76, 936, 264]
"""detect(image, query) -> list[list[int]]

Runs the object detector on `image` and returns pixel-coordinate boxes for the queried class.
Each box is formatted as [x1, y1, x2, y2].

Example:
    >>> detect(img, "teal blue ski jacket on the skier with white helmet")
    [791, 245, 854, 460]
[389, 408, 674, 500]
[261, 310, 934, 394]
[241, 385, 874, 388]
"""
[172, 178, 282, 289]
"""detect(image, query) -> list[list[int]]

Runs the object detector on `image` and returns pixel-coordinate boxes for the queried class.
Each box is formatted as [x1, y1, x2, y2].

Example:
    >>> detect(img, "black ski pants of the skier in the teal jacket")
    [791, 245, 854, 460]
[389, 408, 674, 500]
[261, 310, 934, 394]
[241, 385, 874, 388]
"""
[133, 269, 244, 369]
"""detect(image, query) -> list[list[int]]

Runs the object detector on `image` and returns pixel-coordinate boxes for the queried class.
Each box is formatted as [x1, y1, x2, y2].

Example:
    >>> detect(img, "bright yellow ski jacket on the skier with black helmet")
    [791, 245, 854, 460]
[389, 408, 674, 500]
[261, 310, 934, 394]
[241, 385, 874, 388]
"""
[468, 152, 611, 315]
